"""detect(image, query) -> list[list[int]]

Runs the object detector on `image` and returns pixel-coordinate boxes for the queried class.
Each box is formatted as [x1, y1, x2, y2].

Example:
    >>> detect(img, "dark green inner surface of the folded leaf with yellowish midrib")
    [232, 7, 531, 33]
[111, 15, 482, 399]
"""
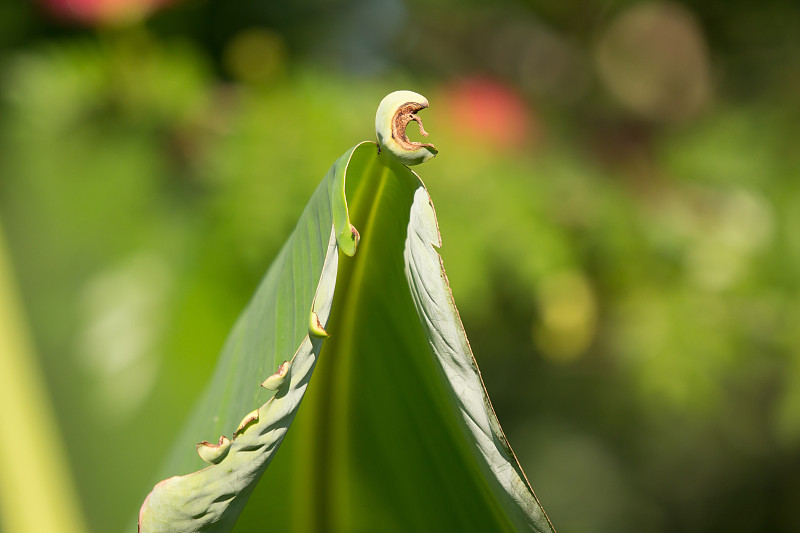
[237, 150, 551, 532]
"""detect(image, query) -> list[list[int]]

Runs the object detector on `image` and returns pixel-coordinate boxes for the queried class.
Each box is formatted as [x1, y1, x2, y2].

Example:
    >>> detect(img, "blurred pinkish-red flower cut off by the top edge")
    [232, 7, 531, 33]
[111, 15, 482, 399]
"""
[39, 0, 174, 26]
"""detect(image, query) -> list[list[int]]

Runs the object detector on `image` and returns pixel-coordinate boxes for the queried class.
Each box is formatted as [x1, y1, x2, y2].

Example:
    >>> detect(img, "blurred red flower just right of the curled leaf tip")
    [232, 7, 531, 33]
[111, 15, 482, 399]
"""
[441, 78, 534, 148]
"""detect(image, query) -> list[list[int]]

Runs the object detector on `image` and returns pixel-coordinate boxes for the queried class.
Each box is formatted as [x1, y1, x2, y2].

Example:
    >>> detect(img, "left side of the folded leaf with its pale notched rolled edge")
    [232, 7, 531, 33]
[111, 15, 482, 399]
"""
[139, 143, 376, 532]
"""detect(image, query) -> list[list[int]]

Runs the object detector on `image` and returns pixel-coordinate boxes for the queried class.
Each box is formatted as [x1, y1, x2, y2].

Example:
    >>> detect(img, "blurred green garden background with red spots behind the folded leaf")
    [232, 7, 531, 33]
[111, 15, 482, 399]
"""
[0, 0, 800, 533]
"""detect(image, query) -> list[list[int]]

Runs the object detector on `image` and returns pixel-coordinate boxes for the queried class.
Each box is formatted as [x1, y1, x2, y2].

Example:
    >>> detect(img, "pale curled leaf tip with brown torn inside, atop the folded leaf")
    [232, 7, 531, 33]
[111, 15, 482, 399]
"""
[375, 91, 438, 165]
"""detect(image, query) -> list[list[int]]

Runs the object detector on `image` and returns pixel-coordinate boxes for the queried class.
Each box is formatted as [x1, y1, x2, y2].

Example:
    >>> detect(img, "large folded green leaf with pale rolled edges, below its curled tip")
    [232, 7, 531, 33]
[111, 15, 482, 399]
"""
[140, 93, 553, 532]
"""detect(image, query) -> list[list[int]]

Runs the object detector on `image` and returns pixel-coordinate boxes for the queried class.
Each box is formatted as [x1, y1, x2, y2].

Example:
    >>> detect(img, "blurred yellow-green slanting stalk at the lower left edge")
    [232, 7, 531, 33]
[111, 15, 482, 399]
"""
[0, 219, 86, 533]
